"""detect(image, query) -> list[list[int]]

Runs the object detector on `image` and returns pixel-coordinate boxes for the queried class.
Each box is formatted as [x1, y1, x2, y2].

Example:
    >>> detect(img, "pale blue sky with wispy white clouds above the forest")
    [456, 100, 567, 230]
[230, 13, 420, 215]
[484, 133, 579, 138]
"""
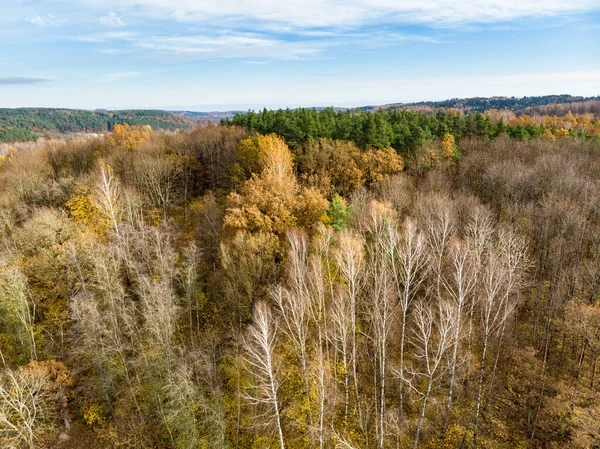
[0, 0, 600, 111]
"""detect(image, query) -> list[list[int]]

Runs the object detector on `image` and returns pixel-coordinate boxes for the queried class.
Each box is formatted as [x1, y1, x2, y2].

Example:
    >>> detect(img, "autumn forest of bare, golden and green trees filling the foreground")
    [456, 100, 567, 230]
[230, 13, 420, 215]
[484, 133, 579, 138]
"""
[0, 110, 600, 449]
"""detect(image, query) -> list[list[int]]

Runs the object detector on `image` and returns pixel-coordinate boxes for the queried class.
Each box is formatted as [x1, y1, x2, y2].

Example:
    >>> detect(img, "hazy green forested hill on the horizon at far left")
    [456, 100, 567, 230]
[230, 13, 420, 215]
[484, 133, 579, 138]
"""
[0, 108, 198, 142]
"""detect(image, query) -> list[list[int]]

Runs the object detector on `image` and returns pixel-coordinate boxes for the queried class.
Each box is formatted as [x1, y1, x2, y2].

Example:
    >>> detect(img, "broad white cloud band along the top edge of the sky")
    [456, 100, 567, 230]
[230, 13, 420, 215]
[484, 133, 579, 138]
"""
[84, 0, 600, 28]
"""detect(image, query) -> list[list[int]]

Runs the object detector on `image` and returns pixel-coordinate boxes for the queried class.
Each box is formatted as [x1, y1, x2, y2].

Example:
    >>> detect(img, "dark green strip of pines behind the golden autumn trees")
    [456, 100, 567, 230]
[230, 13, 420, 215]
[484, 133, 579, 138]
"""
[223, 108, 587, 154]
